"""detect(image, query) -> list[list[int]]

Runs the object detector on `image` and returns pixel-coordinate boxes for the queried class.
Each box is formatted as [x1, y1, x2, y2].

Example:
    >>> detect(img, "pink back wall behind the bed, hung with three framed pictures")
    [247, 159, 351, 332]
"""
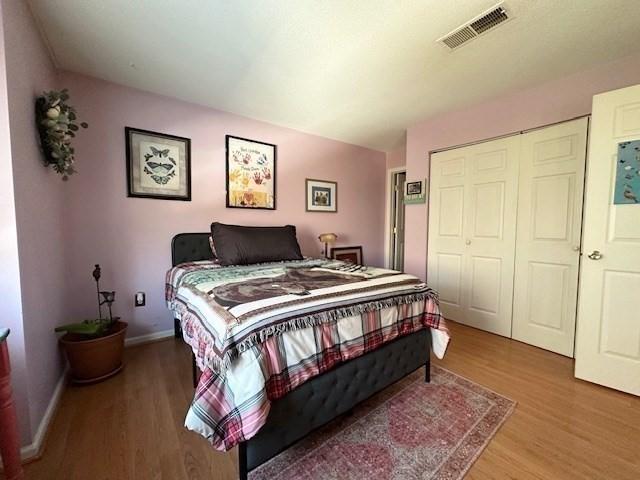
[61, 73, 385, 335]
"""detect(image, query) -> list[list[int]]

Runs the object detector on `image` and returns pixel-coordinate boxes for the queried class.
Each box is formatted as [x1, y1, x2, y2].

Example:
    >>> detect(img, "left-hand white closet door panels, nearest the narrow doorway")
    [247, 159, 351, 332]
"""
[427, 136, 520, 337]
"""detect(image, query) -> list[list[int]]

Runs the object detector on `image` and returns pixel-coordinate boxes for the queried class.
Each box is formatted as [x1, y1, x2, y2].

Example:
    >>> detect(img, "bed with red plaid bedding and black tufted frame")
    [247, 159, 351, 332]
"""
[167, 232, 449, 480]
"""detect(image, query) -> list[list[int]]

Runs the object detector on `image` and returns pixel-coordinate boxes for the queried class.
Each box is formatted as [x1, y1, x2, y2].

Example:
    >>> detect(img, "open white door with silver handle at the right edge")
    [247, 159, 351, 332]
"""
[575, 85, 640, 395]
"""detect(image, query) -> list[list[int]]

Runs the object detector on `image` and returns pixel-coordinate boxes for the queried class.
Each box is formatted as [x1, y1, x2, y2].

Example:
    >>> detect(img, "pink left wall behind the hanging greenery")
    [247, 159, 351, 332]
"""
[2, 0, 66, 444]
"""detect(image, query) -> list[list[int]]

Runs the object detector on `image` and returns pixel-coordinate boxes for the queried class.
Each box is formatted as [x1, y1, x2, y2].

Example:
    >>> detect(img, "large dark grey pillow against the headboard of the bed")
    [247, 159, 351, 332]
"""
[211, 222, 302, 265]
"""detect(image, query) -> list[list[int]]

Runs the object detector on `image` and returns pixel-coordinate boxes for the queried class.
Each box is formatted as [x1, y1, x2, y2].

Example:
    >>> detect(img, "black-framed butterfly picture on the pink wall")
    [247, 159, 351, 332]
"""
[124, 127, 191, 201]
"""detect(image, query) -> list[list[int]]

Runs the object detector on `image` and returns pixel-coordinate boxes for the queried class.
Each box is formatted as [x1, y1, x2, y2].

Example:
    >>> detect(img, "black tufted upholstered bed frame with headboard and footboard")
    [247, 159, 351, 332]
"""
[171, 233, 431, 480]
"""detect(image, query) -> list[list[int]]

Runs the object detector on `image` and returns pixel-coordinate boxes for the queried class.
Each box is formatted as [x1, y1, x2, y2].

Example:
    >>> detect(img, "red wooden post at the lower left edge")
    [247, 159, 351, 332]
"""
[0, 330, 24, 480]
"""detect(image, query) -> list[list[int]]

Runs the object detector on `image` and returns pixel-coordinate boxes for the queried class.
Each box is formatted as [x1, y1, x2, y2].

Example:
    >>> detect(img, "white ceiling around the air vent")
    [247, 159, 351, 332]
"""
[30, 0, 640, 151]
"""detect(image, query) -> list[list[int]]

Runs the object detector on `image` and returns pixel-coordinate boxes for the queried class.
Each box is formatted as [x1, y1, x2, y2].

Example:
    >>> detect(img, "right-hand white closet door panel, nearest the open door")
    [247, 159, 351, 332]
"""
[513, 118, 588, 357]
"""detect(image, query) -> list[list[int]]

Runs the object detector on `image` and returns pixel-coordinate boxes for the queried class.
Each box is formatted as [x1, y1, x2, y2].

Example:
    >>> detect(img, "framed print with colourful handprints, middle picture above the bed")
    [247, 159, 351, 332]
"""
[226, 135, 277, 210]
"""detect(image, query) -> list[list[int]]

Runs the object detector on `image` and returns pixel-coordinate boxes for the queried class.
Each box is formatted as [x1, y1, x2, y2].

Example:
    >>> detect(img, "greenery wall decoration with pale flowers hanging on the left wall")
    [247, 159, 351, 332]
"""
[36, 88, 89, 180]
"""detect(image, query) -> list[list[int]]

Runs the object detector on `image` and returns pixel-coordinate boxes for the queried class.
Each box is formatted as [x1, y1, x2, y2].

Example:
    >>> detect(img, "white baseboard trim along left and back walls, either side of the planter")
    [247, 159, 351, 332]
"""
[20, 329, 174, 463]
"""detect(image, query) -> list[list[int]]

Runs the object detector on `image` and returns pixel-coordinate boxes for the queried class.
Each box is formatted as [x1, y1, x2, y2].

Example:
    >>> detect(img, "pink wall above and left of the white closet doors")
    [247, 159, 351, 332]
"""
[405, 55, 640, 278]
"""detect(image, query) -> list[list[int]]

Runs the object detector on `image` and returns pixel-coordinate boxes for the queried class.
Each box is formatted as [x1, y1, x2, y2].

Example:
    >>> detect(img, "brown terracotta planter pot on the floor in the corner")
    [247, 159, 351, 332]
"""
[60, 321, 127, 383]
